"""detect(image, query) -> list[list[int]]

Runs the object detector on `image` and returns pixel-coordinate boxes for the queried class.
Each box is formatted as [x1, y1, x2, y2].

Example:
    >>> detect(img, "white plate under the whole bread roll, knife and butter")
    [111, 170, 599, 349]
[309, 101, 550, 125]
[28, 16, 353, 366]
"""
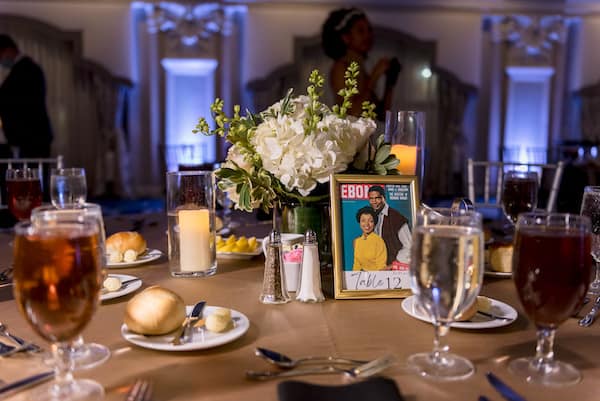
[121, 305, 250, 351]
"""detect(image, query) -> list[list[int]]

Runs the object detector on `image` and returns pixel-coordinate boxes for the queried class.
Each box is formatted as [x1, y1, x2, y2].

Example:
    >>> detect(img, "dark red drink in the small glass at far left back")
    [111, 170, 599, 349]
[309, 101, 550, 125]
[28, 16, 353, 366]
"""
[6, 178, 42, 220]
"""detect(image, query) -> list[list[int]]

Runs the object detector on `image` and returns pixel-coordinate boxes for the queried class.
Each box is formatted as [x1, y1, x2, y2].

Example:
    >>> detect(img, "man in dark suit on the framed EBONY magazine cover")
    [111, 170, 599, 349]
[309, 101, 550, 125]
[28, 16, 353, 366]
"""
[369, 185, 412, 270]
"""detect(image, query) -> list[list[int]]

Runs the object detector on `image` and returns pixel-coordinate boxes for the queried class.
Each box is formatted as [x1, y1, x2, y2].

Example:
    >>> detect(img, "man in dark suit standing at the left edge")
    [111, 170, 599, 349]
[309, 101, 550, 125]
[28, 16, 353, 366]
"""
[0, 34, 52, 157]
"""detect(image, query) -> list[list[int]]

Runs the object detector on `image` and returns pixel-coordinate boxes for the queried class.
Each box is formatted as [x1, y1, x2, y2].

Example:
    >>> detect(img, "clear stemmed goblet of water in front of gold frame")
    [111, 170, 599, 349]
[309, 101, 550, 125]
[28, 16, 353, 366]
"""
[408, 208, 483, 380]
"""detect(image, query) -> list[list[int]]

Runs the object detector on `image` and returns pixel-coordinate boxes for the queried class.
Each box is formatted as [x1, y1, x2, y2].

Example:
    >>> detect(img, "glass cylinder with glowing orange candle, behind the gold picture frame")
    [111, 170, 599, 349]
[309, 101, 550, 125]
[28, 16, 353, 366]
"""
[385, 110, 425, 188]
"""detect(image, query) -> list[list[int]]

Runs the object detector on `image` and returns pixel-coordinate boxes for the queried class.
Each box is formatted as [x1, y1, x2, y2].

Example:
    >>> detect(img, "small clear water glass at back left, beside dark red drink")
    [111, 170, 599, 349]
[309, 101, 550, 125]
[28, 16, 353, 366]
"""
[50, 167, 87, 209]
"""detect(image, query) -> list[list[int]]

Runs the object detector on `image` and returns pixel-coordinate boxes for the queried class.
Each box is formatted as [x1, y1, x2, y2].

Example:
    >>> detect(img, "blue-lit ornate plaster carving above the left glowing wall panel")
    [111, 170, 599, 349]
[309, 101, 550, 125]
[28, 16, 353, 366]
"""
[146, 1, 231, 46]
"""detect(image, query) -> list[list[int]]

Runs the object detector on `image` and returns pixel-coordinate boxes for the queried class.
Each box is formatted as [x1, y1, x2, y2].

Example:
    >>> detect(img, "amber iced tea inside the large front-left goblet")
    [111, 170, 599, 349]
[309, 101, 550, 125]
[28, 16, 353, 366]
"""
[14, 225, 102, 342]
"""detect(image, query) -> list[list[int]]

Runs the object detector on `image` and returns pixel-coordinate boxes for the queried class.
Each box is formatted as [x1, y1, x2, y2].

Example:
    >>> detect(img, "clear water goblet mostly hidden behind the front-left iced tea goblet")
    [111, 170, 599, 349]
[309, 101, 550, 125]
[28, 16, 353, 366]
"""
[31, 203, 110, 370]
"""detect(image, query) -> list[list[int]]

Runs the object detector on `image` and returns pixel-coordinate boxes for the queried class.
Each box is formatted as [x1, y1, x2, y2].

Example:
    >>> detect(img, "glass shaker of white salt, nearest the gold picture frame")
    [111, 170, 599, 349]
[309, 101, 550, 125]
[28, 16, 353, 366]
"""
[296, 230, 325, 302]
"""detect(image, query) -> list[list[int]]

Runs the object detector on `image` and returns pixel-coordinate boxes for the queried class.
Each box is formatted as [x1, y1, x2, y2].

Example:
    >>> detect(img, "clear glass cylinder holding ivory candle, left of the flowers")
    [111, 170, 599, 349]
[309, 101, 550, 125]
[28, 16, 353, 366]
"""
[167, 171, 217, 277]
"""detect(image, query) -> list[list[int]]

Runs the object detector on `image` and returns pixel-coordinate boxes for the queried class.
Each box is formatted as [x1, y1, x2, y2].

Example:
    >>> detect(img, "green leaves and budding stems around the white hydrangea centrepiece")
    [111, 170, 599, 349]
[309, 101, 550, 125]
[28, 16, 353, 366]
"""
[192, 62, 398, 212]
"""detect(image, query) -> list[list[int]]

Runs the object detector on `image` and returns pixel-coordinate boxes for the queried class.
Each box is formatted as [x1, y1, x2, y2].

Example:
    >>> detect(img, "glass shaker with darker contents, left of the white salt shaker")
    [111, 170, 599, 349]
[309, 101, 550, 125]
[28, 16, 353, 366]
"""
[258, 230, 290, 304]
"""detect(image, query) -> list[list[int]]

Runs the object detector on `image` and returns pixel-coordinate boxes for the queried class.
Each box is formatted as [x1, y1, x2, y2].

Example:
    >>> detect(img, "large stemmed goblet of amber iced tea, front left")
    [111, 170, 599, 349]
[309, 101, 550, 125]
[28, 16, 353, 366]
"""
[14, 216, 104, 401]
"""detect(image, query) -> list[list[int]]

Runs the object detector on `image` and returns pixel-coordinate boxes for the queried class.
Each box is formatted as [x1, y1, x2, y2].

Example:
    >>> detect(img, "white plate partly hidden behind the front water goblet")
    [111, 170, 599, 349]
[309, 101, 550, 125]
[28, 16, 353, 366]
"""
[402, 295, 518, 329]
